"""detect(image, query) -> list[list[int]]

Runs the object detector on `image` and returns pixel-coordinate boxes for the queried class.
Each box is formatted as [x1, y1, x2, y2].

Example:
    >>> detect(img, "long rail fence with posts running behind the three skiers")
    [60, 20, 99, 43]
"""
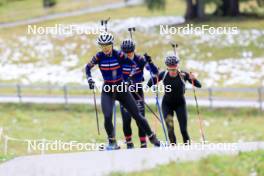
[0, 84, 264, 110]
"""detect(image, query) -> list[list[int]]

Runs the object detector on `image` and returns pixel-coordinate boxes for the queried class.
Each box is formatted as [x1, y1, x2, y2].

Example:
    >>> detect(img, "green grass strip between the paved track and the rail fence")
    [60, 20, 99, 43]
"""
[0, 104, 264, 164]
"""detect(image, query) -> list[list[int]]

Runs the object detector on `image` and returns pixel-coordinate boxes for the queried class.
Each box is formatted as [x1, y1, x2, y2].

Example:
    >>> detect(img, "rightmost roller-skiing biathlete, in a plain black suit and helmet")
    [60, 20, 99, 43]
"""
[147, 56, 202, 144]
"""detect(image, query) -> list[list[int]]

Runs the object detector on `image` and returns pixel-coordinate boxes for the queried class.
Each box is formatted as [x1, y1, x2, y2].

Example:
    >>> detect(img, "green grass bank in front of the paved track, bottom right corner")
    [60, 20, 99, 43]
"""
[111, 150, 264, 176]
